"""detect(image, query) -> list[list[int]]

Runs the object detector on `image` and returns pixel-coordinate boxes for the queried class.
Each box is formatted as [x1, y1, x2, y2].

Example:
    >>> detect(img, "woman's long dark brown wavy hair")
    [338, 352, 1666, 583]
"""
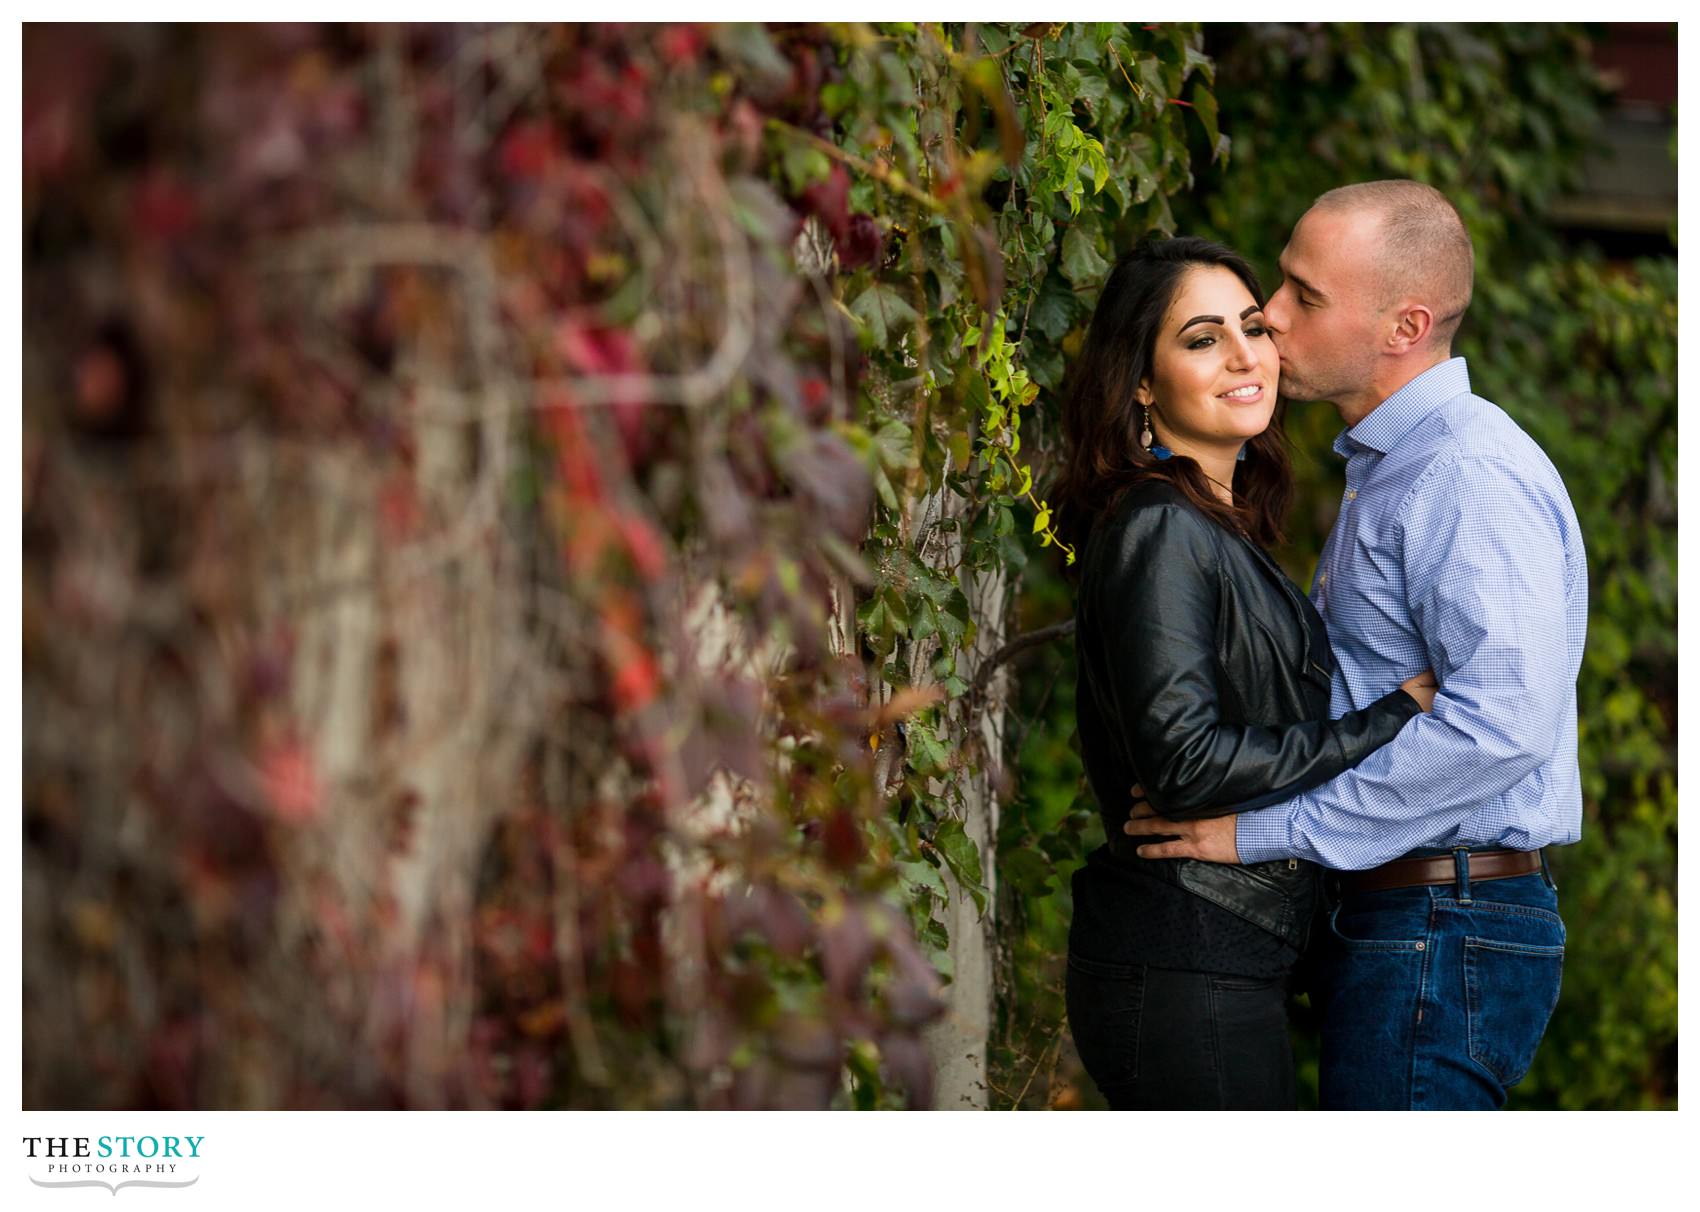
[1052, 236, 1292, 546]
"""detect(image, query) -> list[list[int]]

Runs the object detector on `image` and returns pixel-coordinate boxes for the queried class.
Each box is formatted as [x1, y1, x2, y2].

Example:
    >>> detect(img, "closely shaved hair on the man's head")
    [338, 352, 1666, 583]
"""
[1311, 180, 1476, 348]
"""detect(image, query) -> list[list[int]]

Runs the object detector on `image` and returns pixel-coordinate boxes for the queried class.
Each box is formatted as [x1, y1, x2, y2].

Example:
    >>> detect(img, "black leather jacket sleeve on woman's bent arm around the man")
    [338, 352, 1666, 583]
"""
[1081, 505, 1421, 819]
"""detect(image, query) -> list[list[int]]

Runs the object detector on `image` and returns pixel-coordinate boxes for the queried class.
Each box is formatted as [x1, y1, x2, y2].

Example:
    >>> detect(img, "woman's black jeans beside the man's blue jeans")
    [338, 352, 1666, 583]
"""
[1068, 954, 1295, 1112]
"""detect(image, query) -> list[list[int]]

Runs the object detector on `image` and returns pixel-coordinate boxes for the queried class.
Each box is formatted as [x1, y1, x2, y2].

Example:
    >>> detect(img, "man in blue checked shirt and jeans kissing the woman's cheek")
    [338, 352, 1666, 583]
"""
[1124, 180, 1588, 1108]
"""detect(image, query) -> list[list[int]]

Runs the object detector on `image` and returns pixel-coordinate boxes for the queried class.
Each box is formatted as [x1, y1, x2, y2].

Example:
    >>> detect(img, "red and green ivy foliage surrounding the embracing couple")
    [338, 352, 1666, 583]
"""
[22, 24, 1675, 1108]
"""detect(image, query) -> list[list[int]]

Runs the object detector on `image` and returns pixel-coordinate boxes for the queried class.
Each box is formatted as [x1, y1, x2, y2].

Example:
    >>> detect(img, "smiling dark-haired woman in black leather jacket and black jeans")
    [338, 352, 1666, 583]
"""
[1057, 238, 1433, 1108]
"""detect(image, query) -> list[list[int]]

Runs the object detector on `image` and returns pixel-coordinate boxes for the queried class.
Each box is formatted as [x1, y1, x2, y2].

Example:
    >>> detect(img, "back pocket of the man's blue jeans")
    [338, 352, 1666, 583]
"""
[1464, 926, 1564, 1086]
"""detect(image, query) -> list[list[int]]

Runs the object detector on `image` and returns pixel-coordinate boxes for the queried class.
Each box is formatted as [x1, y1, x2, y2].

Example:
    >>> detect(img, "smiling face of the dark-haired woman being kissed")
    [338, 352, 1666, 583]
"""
[1139, 265, 1280, 457]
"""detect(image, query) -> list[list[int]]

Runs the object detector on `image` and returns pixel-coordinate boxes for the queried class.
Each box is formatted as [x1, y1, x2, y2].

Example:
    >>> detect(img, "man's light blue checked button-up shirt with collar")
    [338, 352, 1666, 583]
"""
[1236, 357, 1588, 870]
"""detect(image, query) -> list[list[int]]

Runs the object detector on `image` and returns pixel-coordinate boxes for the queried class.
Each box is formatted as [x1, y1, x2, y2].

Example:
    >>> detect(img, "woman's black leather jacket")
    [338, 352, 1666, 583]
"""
[1074, 481, 1421, 947]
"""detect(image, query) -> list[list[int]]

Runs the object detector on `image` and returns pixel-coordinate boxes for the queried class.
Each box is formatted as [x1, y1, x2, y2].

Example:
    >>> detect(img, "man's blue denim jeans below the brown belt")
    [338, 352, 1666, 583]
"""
[1319, 869, 1564, 1110]
